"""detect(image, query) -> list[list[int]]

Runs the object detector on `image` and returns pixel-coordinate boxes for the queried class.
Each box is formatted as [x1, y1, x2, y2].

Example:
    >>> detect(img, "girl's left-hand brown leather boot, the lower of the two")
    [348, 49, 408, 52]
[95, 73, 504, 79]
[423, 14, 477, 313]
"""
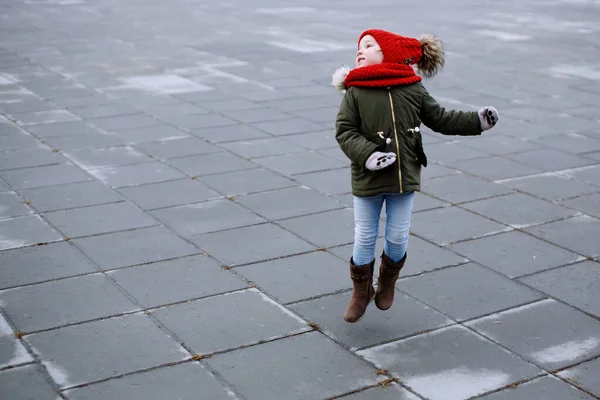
[344, 259, 375, 322]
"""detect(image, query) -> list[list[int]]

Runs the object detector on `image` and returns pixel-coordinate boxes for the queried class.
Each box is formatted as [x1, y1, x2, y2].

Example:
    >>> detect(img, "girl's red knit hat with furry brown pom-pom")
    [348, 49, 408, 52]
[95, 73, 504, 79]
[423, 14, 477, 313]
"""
[358, 29, 444, 77]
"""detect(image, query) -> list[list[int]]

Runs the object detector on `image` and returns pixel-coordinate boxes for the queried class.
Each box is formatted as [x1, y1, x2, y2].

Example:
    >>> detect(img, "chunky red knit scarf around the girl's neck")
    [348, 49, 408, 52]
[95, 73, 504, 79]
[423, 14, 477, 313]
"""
[344, 63, 422, 87]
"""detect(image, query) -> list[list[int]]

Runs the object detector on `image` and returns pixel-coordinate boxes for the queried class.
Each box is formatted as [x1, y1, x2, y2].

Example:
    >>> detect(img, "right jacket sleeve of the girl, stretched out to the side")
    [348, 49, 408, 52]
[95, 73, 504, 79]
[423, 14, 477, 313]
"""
[421, 87, 482, 136]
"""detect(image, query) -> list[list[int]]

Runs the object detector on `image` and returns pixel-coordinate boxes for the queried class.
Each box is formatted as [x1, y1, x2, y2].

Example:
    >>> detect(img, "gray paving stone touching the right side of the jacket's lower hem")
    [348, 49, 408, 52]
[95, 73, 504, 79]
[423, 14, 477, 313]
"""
[421, 174, 511, 204]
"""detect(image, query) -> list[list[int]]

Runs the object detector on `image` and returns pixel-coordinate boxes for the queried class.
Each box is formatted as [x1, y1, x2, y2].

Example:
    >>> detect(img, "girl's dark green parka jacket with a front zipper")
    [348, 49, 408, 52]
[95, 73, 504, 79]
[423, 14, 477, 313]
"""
[336, 82, 482, 197]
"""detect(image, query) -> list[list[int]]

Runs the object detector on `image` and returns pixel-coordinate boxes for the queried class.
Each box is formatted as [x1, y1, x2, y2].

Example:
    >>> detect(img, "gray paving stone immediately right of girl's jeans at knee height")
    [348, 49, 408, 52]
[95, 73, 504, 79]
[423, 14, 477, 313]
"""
[411, 207, 510, 246]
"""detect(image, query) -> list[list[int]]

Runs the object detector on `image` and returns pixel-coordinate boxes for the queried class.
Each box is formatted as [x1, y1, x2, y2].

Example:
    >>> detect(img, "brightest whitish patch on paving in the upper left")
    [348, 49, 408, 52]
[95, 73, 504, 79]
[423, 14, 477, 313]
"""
[121, 74, 213, 94]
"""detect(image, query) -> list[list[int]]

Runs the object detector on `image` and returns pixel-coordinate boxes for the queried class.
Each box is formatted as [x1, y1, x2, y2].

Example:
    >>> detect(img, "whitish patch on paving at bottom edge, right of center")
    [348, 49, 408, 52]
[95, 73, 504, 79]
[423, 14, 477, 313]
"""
[404, 367, 511, 400]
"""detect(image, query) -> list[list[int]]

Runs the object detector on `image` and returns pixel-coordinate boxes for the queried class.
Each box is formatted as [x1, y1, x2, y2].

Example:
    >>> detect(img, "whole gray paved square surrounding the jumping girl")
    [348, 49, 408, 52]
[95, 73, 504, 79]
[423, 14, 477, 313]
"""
[0, 0, 600, 400]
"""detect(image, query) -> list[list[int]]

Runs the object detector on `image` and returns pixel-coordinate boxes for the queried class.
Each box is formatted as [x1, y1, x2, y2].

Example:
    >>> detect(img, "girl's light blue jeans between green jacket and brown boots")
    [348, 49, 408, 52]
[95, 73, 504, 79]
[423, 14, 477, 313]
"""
[352, 192, 415, 265]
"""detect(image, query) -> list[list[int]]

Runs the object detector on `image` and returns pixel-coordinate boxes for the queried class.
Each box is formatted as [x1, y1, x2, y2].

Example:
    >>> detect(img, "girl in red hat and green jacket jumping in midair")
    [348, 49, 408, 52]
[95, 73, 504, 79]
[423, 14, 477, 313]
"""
[332, 29, 498, 322]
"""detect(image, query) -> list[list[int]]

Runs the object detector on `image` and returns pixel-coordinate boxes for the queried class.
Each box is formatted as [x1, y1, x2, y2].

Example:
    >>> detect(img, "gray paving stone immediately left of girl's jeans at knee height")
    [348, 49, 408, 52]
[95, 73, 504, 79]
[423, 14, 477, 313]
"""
[278, 208, 356, 247]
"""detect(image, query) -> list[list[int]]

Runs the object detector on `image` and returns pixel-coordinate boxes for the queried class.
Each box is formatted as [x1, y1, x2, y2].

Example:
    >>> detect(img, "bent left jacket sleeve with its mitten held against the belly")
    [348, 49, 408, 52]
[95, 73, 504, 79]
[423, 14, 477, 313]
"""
[335, 89, 377, 166]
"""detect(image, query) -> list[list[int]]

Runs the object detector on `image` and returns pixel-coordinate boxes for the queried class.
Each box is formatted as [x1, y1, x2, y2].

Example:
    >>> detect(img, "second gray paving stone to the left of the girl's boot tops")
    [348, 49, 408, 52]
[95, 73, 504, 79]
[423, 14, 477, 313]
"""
[109, 256, 248, 308]
